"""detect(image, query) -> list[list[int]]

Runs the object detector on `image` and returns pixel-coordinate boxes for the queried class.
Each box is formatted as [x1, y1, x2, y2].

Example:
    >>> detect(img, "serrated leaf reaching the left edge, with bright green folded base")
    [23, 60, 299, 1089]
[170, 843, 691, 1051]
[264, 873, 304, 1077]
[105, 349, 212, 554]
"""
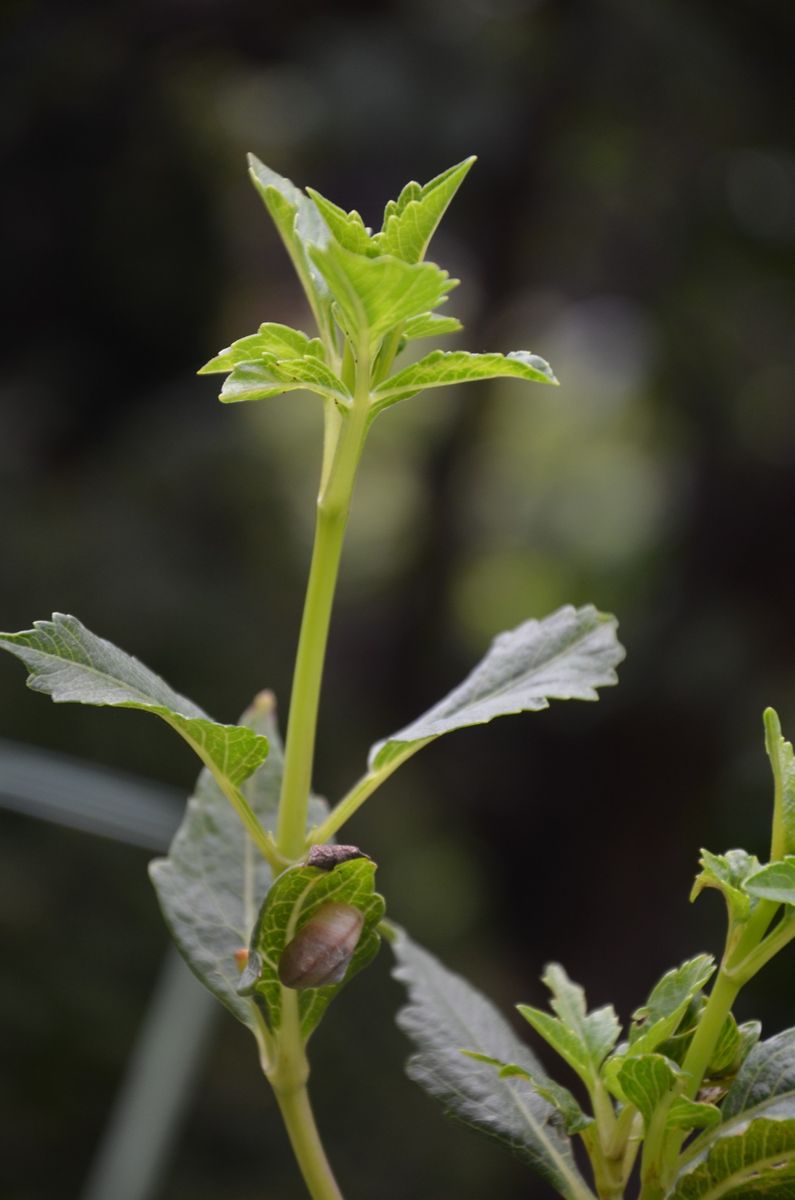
[0, 612, 268, 787]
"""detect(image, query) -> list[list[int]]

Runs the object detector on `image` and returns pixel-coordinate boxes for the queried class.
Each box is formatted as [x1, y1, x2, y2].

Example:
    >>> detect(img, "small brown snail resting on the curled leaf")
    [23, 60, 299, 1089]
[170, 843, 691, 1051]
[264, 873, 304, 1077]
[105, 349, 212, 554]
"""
[279, 900, 364, 989]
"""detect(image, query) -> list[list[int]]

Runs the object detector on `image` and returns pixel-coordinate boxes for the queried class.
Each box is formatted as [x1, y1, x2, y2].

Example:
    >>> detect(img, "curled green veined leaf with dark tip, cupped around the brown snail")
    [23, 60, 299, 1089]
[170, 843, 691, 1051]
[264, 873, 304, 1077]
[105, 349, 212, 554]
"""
[240, 858, 384, 1042]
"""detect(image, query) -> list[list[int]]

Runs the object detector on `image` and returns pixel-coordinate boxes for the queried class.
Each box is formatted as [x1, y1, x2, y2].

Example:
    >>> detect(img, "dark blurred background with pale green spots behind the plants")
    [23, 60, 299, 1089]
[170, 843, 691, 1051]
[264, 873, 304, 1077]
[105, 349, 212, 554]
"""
[0, 0, 795, 1200]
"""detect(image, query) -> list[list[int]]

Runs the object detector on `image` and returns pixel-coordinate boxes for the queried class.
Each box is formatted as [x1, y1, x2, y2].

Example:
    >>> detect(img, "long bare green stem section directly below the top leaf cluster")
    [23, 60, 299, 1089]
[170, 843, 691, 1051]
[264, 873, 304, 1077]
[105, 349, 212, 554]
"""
[276, 354, 370, 860]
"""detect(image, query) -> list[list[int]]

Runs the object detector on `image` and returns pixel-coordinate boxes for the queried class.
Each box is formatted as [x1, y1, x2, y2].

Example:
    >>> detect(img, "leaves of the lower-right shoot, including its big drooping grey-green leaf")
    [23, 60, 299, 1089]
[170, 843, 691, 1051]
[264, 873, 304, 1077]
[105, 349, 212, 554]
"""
[393, 709, 795, 1200]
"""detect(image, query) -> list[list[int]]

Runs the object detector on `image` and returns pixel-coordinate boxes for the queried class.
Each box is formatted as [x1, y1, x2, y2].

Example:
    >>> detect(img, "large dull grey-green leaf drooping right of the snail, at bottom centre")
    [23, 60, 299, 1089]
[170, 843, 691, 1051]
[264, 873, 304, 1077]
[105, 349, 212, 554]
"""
[390, 930, 592, 1200]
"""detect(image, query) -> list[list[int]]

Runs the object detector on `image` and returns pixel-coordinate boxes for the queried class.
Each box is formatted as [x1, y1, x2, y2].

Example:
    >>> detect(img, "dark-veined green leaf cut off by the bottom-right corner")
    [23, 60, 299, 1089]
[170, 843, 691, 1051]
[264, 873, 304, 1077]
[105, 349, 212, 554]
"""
[668, 1118, 795, 1200]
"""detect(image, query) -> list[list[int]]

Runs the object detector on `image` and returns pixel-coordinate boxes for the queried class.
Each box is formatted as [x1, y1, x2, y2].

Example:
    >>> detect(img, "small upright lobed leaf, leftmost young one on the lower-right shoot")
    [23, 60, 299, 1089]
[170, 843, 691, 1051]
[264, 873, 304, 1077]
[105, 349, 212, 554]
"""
[516, 962, 621, 1086]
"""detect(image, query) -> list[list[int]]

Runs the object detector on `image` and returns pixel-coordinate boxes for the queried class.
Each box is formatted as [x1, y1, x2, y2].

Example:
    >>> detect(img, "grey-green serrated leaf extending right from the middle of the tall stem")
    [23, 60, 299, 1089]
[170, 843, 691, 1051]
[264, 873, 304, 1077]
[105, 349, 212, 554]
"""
[369, 605, 624, 772]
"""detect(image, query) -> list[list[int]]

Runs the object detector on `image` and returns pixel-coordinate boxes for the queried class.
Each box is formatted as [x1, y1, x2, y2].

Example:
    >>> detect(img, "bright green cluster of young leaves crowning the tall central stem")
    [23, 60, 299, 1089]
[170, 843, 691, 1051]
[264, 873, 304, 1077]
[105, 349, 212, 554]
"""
[199, 156, 557, 419]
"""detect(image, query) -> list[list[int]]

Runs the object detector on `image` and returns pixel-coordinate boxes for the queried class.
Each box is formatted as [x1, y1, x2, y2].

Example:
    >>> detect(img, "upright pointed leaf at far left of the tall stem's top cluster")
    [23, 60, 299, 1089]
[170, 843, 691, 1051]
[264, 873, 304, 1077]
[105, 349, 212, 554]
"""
[249, 155, 330, 331]
